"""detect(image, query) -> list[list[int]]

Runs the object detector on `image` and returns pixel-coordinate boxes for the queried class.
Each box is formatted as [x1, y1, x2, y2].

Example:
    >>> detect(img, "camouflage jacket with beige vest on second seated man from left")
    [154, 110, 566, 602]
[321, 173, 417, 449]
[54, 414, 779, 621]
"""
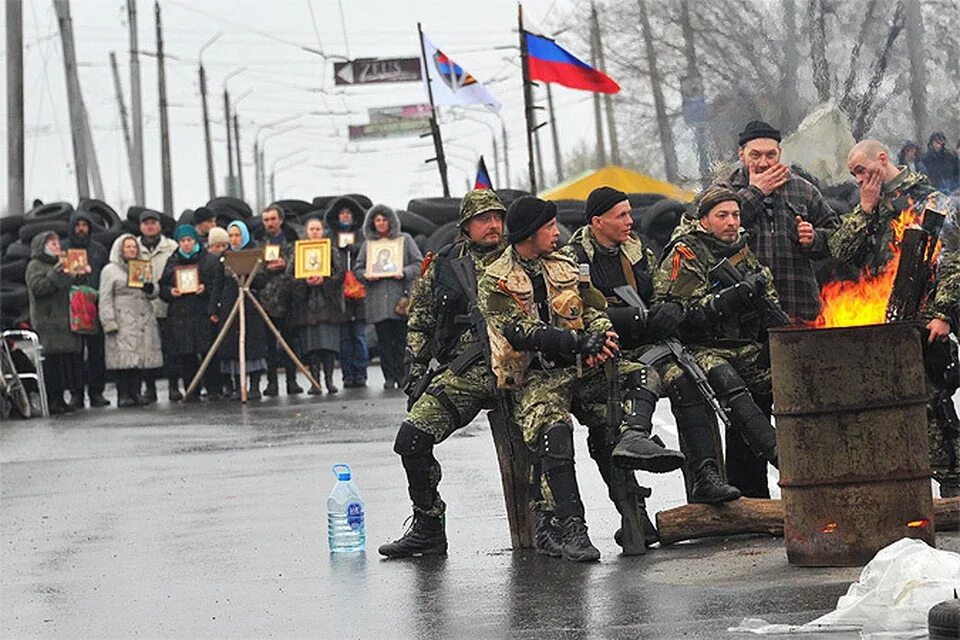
[479, 247, 612, 389]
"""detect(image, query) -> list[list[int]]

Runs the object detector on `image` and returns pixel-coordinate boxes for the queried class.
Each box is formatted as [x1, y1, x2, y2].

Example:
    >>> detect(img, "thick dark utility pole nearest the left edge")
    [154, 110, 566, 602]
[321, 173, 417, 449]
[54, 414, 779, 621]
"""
[6, 0, 26, 216]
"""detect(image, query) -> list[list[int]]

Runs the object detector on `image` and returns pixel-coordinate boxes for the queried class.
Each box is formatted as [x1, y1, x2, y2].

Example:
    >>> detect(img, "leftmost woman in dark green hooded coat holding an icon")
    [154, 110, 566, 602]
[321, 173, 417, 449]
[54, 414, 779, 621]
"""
[25, 231, 91, 414]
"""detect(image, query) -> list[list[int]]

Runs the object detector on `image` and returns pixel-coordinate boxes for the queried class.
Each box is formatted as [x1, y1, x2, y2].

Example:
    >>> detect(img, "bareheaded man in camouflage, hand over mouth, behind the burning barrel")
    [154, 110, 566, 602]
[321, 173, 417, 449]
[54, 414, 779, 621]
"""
[830, 140, 960, 497]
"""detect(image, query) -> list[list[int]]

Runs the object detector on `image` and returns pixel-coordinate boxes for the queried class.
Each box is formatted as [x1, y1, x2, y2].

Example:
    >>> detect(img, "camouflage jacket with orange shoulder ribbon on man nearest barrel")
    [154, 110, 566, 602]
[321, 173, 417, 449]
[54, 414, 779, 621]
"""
[654, 219, 780, 345]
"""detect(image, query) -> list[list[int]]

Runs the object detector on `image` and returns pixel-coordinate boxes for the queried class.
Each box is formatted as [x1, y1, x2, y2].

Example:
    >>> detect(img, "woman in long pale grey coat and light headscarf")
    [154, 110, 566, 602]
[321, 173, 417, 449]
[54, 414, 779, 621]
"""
[99, 233, 163, 408]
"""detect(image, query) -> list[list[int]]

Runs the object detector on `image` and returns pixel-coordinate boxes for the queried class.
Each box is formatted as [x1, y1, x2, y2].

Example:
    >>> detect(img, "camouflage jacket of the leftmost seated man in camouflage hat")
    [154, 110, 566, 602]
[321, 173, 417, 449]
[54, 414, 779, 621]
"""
[407, 239, 503, 370]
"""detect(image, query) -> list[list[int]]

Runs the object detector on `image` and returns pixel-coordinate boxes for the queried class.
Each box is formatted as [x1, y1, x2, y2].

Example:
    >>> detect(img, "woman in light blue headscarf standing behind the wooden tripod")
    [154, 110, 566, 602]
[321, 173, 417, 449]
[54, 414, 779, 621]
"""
[218, 220, 267, 400]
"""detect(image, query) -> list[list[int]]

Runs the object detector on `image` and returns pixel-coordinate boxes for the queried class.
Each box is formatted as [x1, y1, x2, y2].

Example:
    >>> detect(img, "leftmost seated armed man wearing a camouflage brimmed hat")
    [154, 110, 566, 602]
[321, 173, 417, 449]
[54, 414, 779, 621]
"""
[379, 190, 504, 558]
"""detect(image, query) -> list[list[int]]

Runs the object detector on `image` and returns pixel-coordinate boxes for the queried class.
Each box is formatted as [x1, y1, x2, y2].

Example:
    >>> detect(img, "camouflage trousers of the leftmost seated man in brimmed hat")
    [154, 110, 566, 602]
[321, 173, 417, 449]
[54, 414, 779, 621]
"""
[406, 363, 493, 517]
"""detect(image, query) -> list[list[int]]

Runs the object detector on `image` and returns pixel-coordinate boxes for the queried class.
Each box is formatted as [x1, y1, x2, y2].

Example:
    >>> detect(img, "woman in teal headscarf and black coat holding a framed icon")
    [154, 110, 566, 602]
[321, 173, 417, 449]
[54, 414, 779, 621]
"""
[160, 224, 221, 402]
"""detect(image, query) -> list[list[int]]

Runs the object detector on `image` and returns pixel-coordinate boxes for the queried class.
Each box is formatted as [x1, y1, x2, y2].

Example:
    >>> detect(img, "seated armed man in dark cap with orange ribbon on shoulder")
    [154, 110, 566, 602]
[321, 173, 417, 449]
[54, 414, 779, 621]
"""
[654, 185, 785, 490]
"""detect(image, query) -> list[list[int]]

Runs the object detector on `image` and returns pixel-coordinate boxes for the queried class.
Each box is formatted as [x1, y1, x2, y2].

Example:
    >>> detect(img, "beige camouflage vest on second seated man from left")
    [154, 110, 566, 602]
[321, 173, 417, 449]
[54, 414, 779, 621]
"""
[487, 250, 583, 389]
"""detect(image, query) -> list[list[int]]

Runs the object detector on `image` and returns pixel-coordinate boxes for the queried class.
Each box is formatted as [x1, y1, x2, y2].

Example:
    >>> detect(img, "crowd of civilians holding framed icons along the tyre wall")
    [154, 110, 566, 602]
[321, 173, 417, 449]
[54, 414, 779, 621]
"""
[26, 197, 423, 414]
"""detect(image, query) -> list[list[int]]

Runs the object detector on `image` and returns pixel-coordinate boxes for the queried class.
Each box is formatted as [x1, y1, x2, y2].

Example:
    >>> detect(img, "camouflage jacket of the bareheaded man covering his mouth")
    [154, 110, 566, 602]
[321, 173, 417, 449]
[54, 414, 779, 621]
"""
[830, 169, 960, 320]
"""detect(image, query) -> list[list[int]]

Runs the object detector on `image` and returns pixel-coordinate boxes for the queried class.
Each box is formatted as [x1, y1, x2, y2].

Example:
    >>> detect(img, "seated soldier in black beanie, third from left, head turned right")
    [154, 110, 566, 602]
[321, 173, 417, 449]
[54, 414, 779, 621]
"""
[569, 187, 740, 505]
